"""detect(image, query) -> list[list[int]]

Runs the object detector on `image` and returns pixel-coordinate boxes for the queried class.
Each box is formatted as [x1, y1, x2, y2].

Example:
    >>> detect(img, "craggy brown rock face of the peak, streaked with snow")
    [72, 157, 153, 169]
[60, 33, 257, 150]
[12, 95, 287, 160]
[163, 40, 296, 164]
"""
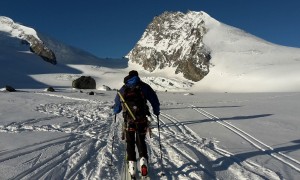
[127, 12, 211, 81]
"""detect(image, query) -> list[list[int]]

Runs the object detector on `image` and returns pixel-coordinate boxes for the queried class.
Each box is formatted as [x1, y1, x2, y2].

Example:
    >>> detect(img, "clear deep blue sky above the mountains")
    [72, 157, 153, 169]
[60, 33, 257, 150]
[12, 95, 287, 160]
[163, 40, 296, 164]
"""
[0, 0, 300, 58]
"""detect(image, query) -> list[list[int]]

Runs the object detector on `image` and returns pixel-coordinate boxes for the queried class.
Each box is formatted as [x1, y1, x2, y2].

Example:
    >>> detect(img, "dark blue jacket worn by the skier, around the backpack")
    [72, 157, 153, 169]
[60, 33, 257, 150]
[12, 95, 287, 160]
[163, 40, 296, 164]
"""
[114, 76, 160, 115]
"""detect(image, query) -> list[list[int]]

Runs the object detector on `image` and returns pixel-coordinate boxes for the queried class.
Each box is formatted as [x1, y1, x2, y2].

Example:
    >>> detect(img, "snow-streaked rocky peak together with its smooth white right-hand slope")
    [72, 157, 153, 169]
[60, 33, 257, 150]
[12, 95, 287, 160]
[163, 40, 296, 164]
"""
[127, 11, 300, 91]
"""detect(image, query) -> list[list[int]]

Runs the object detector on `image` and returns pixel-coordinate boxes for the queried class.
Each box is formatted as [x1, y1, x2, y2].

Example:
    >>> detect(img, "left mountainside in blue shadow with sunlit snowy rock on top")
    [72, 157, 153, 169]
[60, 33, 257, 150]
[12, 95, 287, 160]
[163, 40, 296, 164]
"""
[0, 16, 128, 88]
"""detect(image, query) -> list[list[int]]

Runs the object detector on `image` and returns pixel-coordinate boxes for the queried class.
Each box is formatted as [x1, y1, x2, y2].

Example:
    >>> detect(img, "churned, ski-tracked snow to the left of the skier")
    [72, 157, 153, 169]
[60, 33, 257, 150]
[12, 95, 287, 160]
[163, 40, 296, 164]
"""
[0, 93, 118, 179]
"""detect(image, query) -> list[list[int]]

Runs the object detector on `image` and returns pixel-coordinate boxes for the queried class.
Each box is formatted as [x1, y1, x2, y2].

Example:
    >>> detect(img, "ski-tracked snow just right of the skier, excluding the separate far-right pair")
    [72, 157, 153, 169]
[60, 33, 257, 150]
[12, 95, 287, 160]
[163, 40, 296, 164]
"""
[157, 114, 279, 179]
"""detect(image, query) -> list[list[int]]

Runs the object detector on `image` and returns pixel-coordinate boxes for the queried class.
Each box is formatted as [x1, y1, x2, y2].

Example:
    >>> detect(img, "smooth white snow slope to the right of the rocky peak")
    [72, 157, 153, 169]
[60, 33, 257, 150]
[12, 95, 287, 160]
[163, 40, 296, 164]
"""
[198, 15, 300, 92]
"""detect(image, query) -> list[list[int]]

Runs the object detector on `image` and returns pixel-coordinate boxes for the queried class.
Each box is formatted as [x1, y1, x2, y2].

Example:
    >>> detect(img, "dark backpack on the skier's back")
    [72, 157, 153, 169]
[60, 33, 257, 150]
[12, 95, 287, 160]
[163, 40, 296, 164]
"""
[123, 84, 150, 121]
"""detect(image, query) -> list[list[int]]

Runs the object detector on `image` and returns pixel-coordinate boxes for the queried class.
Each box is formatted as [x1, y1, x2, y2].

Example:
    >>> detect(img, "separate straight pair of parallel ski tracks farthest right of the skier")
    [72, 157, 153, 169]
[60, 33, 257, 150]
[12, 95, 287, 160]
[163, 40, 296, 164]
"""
[190, 105, 300, 173]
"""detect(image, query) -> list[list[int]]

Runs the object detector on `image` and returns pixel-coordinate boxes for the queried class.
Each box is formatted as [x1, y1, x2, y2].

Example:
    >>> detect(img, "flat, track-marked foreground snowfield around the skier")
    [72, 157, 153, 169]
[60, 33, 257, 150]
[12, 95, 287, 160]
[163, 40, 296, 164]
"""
[0, 88, 300, 179]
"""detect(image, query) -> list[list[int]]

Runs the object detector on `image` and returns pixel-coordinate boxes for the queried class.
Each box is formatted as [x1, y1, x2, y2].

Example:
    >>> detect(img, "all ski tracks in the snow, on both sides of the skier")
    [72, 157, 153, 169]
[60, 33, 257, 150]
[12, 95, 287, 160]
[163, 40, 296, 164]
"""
[0, 93, 284, 180]
